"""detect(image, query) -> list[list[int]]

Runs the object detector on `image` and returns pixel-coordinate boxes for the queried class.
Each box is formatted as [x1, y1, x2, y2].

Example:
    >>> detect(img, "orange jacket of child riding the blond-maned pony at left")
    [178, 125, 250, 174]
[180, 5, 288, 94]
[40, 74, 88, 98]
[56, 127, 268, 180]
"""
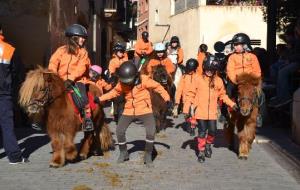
[48, 46, 91, 82]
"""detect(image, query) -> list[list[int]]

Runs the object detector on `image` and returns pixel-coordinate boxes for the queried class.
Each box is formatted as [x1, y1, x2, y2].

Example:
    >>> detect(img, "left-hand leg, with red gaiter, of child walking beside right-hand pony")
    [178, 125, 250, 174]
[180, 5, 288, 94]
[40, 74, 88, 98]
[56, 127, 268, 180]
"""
[197, 120, 207, 163]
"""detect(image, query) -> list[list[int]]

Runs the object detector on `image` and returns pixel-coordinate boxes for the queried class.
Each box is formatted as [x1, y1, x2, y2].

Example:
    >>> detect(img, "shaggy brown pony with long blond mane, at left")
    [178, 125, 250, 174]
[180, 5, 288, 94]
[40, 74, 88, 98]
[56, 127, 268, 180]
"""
[19, 67, 112, 167]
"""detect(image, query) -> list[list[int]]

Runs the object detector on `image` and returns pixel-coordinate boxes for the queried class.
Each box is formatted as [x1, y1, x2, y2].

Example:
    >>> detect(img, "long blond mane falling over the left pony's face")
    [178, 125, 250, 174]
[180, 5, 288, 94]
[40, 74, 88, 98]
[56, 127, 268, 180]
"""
[19, 66, 52, 107]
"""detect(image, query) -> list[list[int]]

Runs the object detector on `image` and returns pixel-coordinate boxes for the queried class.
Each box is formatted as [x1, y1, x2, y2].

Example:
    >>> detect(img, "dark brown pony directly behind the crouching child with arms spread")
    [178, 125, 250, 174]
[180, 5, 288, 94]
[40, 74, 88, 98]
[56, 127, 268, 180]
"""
[150, 65, 173, 132]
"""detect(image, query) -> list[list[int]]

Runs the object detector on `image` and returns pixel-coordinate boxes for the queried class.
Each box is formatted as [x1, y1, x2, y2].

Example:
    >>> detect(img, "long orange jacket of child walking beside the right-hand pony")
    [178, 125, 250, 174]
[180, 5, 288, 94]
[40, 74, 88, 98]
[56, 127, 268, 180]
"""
[193, 75, 235, 120]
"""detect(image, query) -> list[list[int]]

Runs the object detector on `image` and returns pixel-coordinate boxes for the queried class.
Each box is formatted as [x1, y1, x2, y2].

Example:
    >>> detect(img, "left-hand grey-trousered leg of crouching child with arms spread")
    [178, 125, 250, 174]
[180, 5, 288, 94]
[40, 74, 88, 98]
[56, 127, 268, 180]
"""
[116, 115, 134, 163]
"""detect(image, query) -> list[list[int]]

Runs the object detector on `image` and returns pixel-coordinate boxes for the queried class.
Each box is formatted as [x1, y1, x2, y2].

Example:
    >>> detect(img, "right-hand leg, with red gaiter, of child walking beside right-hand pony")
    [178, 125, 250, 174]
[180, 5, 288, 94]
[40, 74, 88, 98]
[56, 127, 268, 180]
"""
[205, 120, 217, 158]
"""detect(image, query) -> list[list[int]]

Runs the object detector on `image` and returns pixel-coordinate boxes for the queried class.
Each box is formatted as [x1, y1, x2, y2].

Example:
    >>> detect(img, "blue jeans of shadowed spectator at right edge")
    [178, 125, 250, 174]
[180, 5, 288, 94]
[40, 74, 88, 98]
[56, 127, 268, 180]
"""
[277, 62, 300, 101]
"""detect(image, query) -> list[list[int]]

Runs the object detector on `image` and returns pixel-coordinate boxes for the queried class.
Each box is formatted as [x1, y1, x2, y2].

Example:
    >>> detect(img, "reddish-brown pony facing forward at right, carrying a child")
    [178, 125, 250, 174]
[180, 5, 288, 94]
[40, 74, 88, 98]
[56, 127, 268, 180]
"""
[226, 73, 261, 160]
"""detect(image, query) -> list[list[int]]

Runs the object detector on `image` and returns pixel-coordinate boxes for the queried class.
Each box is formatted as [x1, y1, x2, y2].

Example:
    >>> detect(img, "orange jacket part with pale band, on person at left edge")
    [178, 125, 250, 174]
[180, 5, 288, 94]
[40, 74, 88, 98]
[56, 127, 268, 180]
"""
[0, 35, 15, 64]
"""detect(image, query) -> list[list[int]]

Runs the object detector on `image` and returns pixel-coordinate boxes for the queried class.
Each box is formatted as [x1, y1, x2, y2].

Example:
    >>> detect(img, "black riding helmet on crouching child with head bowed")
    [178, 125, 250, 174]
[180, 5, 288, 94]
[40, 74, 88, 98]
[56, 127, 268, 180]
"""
[117, 61, 138, 84]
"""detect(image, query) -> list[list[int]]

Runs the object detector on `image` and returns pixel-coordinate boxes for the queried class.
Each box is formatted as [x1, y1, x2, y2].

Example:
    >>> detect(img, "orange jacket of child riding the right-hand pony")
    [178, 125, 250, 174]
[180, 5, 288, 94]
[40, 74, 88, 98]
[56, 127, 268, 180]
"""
[226, 52, 261, 84]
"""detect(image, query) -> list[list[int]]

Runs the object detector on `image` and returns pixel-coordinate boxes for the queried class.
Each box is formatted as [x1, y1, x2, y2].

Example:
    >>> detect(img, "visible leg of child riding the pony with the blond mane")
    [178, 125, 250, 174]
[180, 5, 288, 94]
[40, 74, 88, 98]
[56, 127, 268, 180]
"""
[76, 82, 94, 131]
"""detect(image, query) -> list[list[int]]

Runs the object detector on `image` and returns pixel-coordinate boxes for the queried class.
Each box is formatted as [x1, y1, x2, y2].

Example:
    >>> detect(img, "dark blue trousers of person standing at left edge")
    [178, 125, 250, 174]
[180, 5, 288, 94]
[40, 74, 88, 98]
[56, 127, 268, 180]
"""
[0, 96, 22, 162]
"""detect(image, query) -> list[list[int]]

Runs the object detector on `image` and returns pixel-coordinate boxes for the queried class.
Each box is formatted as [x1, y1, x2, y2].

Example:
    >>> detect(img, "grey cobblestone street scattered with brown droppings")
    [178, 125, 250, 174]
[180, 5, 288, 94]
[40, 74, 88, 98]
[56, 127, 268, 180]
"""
[0, 108, 300, 190]
